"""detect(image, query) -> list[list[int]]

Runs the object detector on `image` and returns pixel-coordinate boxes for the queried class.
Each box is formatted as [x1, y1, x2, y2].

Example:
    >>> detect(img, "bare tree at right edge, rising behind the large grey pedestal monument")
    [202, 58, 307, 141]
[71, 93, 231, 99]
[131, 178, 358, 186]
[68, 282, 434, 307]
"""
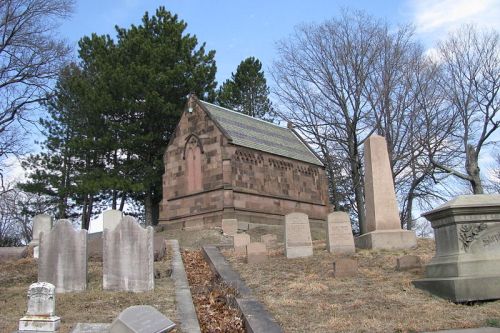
[433, 26, 500, 194]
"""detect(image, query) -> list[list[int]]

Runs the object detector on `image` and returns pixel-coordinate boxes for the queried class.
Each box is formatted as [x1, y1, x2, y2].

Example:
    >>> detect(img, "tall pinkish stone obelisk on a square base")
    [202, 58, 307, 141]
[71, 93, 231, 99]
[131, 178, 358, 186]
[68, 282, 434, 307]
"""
[355, 135, 417, 249]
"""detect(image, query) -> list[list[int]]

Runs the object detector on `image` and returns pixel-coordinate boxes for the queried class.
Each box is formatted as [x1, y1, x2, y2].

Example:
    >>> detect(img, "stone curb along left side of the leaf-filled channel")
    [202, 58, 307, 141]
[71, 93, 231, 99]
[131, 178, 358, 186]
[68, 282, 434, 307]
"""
[167, 239, 201, 333]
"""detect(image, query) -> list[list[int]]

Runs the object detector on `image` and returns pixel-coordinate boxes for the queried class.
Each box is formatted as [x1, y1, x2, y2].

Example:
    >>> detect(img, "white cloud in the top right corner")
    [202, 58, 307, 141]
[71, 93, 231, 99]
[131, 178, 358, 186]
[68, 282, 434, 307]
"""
[409, 0, 500, 34]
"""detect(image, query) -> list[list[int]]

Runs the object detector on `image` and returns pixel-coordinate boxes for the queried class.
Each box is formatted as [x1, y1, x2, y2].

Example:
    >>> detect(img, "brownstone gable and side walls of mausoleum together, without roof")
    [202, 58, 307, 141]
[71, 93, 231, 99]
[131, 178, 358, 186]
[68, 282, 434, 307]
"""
[160, 99, 329, 228]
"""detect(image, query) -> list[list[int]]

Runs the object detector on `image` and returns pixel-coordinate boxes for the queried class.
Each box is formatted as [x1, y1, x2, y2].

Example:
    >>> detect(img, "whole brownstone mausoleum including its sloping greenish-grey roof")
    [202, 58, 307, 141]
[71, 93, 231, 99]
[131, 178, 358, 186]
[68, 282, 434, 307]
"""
[160, 96, 329, 228]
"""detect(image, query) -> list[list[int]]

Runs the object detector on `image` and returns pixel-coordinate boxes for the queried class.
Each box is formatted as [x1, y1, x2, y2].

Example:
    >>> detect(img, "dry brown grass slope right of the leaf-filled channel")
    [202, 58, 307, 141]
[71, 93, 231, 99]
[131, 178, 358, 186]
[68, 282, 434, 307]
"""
[224, 240, 500, 333]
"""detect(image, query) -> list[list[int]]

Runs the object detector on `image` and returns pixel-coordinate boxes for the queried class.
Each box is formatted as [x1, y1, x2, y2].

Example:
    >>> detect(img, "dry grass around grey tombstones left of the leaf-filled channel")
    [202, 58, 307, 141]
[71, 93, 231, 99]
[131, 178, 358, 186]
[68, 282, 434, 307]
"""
[0, 251, 179, 333]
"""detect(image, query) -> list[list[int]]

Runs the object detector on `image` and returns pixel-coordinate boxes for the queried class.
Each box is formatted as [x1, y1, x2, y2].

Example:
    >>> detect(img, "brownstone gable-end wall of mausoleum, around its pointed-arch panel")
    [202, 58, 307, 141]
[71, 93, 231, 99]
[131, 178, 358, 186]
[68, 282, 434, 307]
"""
[160, 104, 226, 223]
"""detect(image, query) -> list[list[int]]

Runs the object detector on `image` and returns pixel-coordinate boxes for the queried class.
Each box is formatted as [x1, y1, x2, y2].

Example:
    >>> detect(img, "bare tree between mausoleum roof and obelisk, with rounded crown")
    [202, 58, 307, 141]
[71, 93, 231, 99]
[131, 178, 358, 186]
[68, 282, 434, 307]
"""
[272, 11, 384, 233]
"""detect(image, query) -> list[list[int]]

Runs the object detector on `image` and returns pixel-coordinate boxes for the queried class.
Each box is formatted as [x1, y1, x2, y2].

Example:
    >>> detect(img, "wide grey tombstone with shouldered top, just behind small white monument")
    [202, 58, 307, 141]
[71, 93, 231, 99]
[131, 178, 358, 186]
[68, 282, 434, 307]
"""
[38, 220, 87, 293]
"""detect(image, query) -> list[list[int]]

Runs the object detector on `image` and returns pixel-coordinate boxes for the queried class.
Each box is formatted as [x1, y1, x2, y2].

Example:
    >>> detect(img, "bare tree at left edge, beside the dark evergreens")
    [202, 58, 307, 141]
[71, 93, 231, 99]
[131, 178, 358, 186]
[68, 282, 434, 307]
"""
[0, 0, 73, 182]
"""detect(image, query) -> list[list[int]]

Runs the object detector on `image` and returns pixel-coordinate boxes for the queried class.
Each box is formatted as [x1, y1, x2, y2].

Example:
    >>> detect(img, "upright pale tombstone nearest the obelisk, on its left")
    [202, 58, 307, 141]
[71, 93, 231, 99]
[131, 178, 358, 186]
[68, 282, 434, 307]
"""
[326, 212, 356, 253]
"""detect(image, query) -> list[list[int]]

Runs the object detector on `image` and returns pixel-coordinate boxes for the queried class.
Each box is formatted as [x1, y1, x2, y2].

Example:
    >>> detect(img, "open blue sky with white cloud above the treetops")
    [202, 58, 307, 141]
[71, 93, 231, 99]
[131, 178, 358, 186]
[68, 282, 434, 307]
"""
[60, 0, 500, 84]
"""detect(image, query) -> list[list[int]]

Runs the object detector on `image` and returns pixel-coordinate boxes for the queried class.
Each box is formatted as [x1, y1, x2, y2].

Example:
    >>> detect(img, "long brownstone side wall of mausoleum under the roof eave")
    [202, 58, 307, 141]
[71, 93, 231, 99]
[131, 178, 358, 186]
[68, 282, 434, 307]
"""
[226, 145, 328, 224]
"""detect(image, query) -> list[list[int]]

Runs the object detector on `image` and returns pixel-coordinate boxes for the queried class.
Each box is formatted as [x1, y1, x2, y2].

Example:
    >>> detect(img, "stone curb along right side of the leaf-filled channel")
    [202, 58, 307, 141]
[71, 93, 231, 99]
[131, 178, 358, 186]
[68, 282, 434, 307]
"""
[202, 245, 283, 333]
